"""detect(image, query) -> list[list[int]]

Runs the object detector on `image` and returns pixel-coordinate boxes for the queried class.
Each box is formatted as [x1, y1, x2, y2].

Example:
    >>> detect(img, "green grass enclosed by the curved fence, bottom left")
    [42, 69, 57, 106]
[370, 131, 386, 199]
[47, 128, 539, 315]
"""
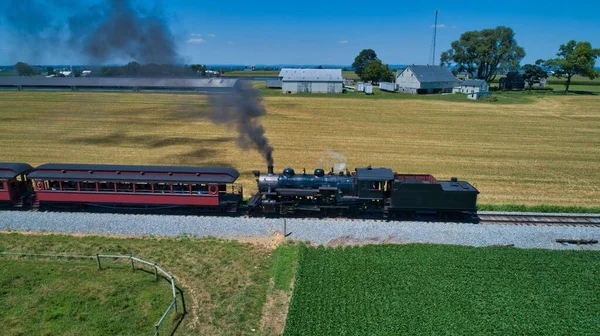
[0, 256, 174, 336]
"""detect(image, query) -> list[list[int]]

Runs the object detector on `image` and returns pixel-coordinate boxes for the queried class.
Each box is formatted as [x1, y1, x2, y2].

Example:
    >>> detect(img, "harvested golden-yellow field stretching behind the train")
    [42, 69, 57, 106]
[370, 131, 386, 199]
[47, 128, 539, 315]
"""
[0, 92, 600, 206]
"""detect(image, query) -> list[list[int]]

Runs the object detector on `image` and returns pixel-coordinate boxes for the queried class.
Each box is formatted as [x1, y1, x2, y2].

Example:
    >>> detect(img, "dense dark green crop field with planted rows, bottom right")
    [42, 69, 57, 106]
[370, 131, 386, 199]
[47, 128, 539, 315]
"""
[285, 244, 600, 336]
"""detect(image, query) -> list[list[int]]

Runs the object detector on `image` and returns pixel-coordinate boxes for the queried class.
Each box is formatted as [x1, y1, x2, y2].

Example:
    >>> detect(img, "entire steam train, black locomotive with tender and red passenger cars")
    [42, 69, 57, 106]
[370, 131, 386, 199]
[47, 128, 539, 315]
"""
[0, 163, 479, 219]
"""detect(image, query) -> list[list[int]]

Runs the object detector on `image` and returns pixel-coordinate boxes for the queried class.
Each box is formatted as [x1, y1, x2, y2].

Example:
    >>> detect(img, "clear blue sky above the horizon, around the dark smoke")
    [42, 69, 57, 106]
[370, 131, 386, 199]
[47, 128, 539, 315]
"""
[0, 0, 600, 65]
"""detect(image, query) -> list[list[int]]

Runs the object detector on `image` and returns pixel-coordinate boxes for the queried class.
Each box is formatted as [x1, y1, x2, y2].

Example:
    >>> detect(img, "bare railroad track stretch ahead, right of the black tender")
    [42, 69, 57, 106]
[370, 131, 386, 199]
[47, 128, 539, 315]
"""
[479, 213, 600, 227]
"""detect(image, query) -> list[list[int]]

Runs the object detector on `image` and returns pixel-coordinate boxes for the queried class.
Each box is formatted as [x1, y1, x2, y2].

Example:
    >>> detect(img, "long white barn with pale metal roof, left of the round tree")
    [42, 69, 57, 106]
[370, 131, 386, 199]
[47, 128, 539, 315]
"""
[279, 68, 344, 93]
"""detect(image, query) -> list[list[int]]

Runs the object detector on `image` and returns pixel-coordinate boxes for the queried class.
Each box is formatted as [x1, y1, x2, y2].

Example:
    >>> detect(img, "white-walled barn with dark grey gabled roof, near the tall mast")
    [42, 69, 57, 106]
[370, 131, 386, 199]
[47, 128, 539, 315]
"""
[396, 65, 459, 94]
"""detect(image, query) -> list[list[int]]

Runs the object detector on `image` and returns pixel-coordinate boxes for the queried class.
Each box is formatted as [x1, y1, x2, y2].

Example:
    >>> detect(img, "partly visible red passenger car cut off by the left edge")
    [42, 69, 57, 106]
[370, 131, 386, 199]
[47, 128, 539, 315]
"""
[0, 162, 33, 207]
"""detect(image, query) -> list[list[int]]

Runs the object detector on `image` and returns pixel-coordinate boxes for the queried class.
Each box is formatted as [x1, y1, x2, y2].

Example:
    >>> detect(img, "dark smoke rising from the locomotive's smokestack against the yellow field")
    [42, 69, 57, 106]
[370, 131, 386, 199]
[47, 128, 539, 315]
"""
[209, 81, 273, 166]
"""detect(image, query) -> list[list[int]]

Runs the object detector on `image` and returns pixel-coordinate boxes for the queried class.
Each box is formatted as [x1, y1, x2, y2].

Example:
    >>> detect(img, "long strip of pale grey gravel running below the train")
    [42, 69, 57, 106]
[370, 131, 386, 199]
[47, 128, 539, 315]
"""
[0, 211, 600, 250]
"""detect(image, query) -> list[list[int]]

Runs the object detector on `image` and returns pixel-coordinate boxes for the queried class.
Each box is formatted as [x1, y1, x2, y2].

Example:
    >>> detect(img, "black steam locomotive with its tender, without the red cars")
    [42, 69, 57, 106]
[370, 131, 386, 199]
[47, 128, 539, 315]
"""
[248, 166, 479, 219]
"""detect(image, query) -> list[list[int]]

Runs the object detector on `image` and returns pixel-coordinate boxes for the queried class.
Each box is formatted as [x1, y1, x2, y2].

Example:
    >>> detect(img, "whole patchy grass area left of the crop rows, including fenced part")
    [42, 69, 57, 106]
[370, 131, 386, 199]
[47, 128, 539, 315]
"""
[0, 232, 295, 336]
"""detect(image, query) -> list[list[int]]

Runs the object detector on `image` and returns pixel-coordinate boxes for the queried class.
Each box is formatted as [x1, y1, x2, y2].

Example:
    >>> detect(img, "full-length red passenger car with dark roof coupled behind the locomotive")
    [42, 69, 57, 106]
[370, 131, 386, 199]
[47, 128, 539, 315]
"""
[29, 164, 242, 212]
